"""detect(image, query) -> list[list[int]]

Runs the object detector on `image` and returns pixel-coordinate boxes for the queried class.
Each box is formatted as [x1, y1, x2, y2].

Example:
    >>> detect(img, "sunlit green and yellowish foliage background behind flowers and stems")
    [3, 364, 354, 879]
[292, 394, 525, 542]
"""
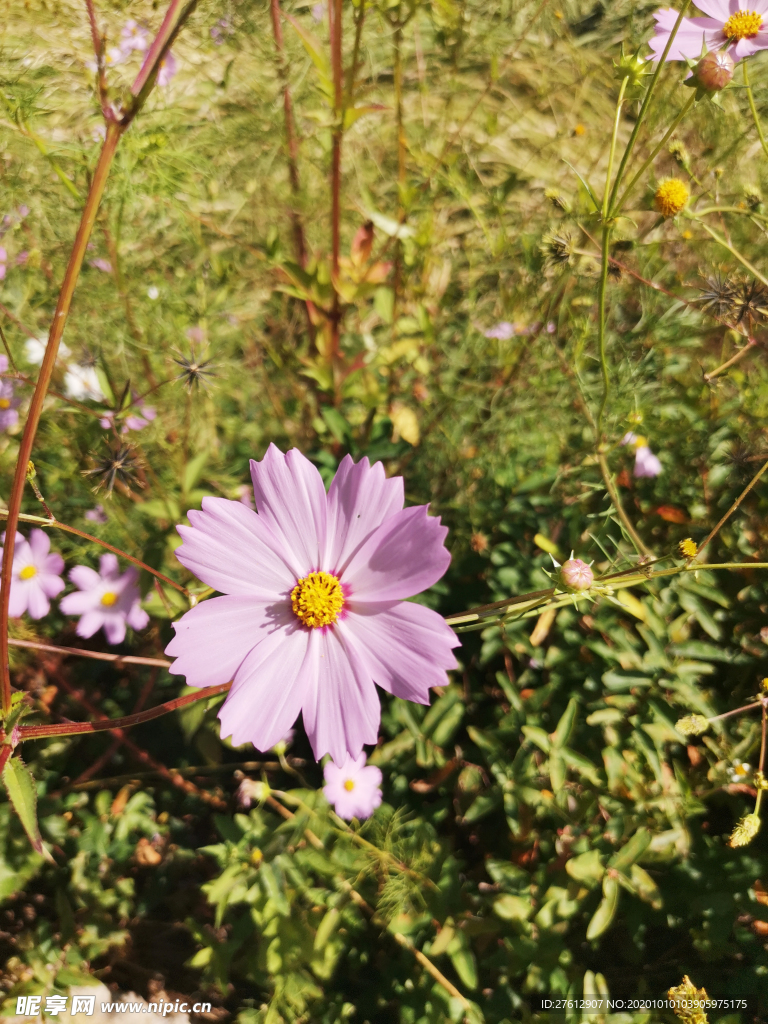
[0, 0, 768, 1024]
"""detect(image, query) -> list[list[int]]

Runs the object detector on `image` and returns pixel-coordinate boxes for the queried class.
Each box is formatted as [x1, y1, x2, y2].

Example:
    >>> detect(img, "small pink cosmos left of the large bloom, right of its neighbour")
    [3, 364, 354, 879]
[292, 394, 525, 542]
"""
[59, 552, 150, 644]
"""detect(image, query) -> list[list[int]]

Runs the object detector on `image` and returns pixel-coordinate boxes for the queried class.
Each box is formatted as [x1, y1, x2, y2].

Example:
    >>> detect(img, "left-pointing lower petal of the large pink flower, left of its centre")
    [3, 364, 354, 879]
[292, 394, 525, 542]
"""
[165, 596, 295, 686]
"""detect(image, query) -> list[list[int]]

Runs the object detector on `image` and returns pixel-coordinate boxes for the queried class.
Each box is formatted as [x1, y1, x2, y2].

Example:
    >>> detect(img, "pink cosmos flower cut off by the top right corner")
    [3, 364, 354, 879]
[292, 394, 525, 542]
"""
[650, 0, 768, 60]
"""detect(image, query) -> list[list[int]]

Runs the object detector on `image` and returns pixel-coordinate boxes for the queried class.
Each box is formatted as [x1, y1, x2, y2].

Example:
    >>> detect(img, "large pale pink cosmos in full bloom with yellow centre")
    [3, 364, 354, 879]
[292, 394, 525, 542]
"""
[166, 444, 459, 764]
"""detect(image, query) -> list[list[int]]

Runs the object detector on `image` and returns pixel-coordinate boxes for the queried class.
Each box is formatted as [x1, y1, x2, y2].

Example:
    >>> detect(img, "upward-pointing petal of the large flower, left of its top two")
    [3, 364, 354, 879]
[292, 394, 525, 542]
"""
[249, 444, 327, 578]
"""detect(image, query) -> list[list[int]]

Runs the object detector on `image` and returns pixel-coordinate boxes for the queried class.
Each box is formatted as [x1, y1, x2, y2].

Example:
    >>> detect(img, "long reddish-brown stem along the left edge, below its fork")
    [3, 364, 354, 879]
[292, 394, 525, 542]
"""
[0, 123, 122, 713]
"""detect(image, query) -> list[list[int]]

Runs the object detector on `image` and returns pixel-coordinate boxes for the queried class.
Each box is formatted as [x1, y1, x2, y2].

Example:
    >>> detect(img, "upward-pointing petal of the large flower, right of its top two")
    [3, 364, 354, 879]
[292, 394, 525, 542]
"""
[323, 455, 403, 575]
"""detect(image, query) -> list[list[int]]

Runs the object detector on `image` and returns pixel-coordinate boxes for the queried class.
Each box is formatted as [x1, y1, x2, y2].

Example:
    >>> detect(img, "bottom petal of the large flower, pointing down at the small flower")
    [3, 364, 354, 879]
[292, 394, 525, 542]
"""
[301, 629, 381, 764]
